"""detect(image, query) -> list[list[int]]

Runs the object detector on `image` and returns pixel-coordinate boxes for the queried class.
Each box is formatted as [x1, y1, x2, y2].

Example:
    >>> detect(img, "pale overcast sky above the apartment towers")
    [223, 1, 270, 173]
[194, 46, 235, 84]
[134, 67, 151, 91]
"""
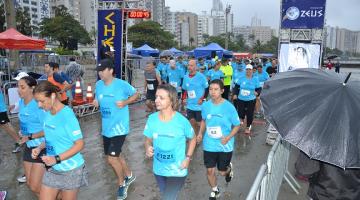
[165, 0, 360, 31]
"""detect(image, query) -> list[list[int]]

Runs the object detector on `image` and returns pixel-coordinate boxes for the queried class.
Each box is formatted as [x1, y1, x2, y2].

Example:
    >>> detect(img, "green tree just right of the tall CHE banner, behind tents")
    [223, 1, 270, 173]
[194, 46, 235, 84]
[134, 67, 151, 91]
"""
[128, 21, 176, 49]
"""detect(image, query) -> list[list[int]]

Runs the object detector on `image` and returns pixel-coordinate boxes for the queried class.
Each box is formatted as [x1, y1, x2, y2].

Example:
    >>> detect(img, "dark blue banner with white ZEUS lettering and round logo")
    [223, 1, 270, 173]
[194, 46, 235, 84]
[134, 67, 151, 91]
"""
[281, 0, 326, 29]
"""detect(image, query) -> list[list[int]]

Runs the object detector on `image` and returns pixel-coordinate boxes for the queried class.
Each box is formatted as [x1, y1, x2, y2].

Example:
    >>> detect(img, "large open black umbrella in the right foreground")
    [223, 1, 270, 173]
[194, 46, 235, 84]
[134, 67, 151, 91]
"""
[261, 69, 360, 168]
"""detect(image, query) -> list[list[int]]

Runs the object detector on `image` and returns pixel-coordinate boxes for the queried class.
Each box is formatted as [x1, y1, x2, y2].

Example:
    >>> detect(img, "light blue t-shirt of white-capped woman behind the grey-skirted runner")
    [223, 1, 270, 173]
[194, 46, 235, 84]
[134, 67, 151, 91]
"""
[18, 99, 46, 148]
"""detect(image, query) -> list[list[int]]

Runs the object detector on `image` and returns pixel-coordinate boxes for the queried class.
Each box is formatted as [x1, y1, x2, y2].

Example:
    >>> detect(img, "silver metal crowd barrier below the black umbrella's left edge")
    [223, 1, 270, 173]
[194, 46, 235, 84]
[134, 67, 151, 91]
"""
[246, 136, 301, 200]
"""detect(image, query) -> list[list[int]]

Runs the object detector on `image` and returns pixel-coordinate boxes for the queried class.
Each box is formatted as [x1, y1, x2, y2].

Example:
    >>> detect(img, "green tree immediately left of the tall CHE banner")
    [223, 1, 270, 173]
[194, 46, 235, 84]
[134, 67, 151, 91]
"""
[40, 6, 91, 49]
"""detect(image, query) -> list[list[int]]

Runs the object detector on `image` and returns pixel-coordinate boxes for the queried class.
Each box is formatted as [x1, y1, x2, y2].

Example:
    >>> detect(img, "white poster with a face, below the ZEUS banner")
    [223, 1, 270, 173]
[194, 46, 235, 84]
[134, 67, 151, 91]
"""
[279, 43, 320, 72]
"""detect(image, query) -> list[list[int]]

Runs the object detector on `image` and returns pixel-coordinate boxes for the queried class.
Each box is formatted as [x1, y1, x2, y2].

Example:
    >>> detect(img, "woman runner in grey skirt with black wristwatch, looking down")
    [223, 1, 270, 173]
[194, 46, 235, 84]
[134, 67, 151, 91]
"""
[32, 81, 87, 200]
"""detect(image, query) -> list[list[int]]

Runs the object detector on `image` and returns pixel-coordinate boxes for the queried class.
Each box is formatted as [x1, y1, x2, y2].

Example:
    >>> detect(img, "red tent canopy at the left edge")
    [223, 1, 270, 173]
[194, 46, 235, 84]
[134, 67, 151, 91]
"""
[0, 28, 46, 50]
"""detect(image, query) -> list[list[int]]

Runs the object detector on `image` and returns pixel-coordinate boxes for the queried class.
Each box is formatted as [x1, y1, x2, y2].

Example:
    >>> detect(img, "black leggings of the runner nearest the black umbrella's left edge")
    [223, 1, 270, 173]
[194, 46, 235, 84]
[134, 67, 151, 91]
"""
[234, 99, 256, 128]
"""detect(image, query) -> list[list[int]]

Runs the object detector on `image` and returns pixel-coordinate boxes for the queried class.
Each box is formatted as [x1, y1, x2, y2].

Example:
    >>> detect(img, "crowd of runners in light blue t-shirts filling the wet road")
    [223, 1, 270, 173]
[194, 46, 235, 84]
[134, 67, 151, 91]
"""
[0, 54, 277, 200]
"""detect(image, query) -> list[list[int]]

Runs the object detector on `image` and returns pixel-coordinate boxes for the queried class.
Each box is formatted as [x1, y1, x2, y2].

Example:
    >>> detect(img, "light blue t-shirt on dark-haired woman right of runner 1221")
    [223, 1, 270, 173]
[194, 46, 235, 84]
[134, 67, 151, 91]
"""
[201, 100, 240, 152]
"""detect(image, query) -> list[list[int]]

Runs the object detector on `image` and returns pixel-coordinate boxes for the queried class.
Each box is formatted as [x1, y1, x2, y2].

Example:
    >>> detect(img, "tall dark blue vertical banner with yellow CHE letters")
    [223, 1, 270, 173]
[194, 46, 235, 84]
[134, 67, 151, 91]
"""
[97, 9, 123, 78]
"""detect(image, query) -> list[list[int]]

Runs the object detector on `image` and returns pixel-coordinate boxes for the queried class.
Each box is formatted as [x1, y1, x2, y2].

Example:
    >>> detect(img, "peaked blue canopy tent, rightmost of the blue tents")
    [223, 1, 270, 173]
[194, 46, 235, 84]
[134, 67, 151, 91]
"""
[194, 43, 232, 58]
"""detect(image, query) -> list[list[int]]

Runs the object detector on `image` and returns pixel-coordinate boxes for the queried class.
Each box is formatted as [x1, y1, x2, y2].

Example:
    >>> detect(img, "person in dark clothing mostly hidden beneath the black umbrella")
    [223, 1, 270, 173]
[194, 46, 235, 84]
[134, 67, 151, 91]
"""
[308, 161, 360, 200]
